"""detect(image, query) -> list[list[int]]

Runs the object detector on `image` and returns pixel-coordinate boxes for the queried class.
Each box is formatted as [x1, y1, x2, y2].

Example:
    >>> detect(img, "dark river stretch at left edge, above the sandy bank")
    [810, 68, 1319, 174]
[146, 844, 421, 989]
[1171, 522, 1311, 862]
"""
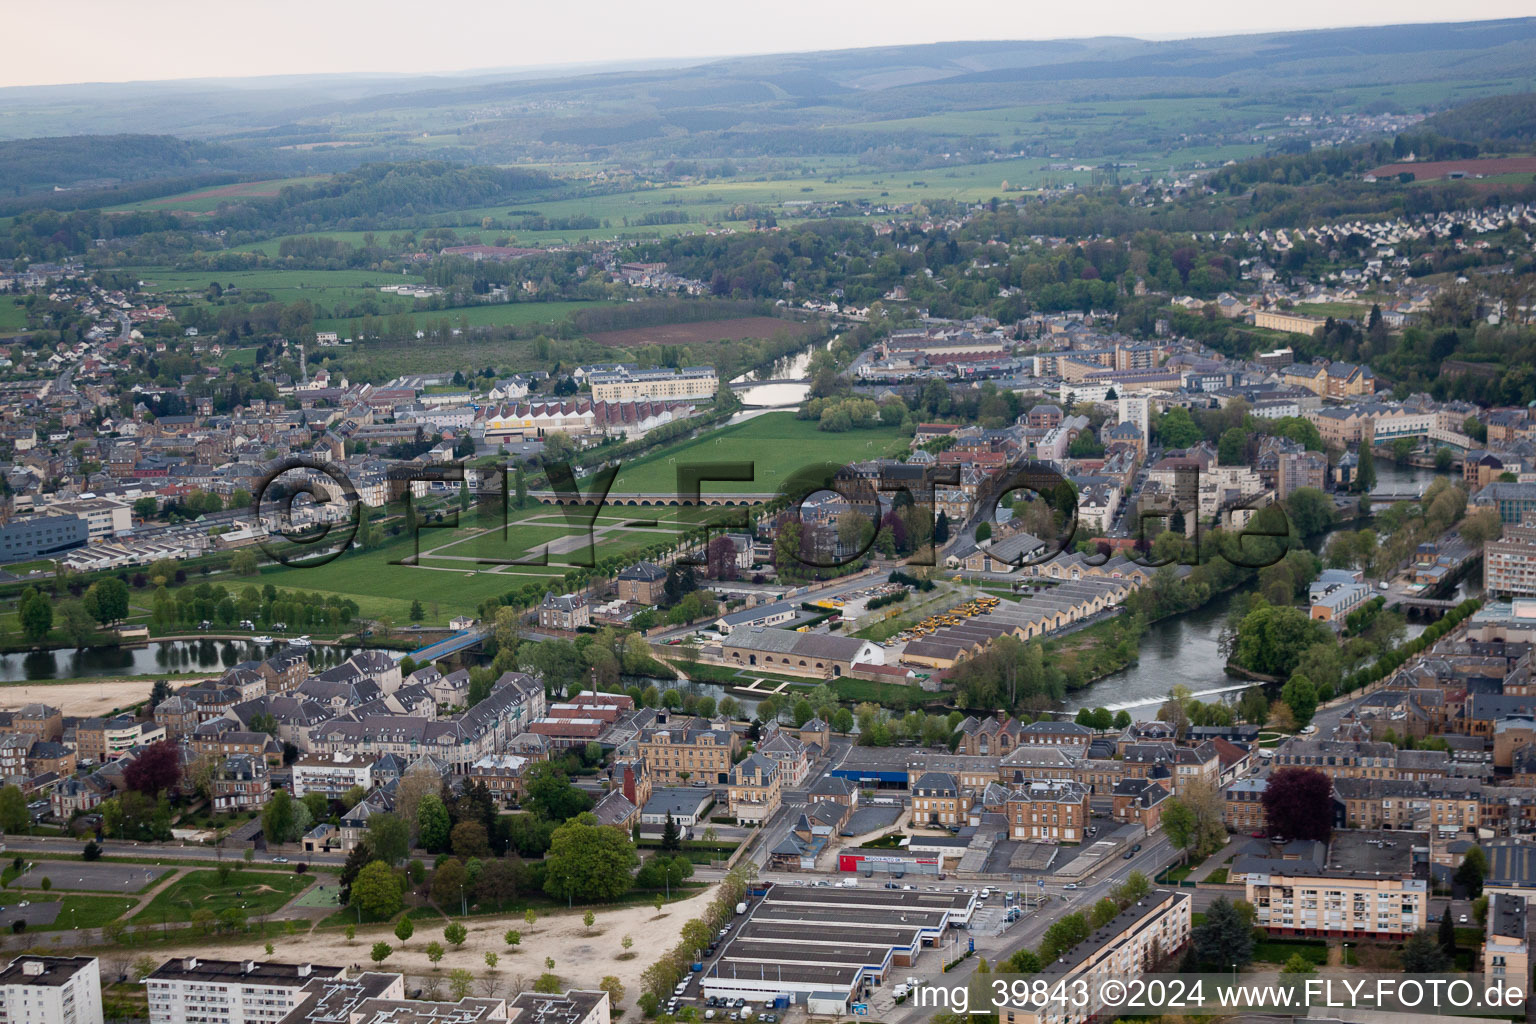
[0, 640, 404, 683]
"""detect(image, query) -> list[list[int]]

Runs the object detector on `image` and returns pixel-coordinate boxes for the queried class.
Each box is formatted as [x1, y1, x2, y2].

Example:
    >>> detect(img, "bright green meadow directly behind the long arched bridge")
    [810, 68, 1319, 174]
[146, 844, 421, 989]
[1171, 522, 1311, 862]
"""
[599, 413, 908, 497]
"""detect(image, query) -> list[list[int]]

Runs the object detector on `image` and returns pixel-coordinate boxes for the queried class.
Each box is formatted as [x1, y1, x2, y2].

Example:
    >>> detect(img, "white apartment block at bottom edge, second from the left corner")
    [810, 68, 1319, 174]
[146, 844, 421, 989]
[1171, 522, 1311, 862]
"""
[144, 956, 347, 1024]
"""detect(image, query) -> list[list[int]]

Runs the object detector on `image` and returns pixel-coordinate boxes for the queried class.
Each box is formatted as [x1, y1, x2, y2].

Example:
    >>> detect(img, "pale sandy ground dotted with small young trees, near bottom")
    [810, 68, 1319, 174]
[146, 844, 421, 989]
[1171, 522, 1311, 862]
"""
[133, 886, 716, 1006]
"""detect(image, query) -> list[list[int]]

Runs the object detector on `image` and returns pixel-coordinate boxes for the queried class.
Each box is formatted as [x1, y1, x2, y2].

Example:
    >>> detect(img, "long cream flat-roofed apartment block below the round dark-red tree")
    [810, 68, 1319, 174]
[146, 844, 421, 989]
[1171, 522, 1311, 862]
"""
[1230, 831, 1430, 940]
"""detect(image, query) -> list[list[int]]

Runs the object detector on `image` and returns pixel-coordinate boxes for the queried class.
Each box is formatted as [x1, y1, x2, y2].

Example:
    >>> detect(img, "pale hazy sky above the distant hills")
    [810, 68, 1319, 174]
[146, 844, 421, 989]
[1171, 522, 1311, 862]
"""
[0, 0, 1533, 86]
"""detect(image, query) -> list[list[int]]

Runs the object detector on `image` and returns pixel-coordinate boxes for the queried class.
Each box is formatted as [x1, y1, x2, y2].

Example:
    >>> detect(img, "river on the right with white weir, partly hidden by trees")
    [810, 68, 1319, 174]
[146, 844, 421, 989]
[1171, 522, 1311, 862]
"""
[1063, 459, 1476, 711]
